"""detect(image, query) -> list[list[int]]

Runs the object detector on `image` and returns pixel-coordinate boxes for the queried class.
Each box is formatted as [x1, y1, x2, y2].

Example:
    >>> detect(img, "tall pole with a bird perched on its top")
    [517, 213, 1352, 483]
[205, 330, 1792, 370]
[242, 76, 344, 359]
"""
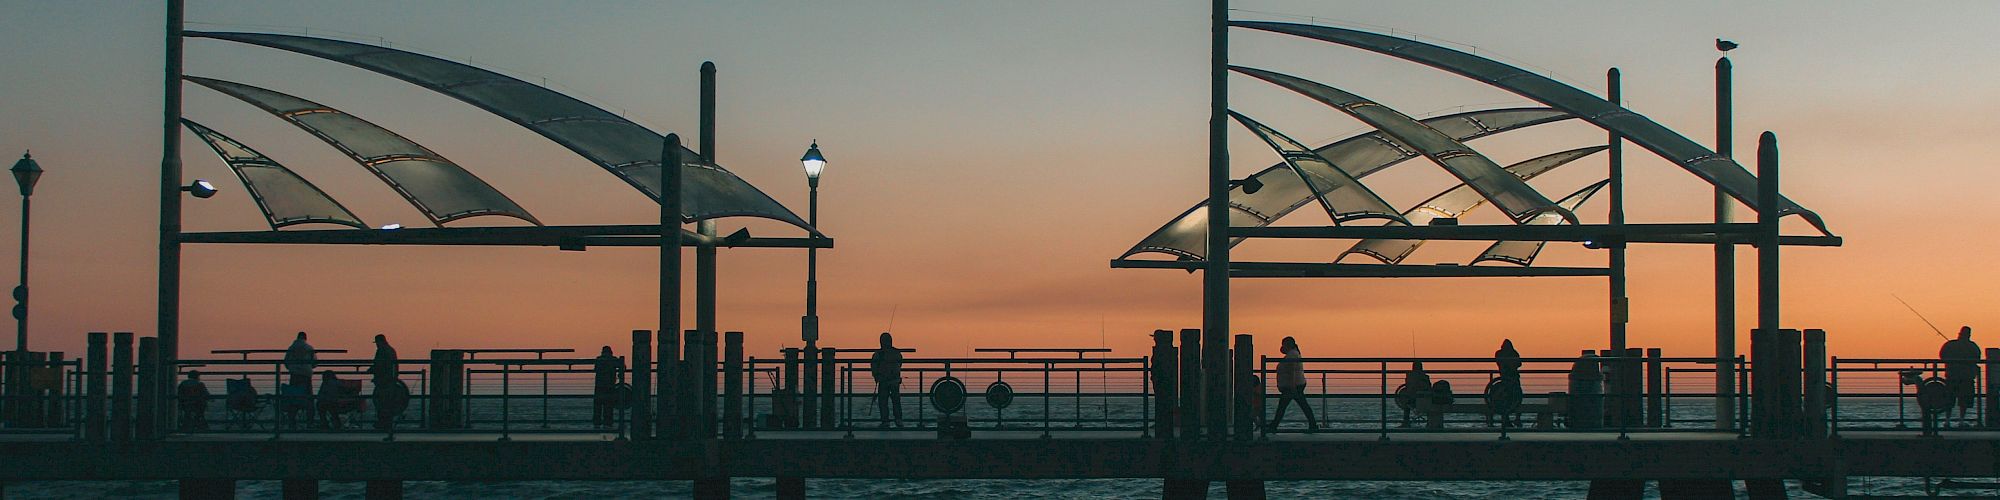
[1716, 56, 1736, 430]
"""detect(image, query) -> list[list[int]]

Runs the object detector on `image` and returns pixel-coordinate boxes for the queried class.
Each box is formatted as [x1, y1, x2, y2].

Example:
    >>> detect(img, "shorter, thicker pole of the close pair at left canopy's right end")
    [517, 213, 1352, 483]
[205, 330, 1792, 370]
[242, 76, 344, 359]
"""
[654, 134, 682, 436]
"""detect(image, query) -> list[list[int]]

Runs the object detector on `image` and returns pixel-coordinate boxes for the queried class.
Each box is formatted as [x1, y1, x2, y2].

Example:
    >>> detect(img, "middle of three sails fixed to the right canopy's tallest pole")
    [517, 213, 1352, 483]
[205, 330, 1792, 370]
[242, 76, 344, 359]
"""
[1230, 66, 1576, 222]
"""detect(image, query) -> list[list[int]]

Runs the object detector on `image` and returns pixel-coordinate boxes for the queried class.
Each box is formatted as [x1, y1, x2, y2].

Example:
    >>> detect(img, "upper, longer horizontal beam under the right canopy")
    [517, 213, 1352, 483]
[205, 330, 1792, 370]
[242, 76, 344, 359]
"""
[1230, 222, 1842, 246]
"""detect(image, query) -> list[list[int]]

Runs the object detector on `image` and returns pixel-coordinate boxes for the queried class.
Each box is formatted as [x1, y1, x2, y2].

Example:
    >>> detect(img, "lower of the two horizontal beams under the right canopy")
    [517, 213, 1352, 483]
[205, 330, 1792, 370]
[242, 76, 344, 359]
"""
[1112, 260, 1610, 278]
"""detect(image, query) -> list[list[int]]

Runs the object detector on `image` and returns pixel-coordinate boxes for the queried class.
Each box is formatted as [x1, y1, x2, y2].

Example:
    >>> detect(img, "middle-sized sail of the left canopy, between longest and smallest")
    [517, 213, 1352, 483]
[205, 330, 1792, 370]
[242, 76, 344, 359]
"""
[186, 76, 542, 226]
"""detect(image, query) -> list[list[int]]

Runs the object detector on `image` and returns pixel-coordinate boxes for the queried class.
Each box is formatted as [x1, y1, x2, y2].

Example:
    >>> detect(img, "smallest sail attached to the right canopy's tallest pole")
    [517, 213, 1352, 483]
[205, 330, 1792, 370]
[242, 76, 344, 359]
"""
[1230, 112, 1410, 226]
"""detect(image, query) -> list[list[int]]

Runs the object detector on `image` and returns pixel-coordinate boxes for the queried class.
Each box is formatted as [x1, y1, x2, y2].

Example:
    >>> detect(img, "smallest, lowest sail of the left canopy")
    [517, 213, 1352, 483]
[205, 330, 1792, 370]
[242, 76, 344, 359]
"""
[180, 118, 368, 230]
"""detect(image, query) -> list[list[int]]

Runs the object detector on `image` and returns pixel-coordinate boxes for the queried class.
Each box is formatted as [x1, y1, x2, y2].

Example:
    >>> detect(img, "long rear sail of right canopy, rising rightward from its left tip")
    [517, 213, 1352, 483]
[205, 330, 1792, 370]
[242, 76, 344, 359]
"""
[1118, 108, 1574, 260]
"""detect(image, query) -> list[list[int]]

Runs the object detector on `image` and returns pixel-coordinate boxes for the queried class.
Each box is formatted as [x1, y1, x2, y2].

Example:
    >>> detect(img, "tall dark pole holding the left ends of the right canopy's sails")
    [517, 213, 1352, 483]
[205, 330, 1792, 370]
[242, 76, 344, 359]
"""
[1202, 0, 1230, 376]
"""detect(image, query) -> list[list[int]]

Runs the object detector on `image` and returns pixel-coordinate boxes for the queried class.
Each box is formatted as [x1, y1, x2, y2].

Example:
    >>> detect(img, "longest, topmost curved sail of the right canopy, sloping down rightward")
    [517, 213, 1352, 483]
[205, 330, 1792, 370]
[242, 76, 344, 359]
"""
[1230, 20, 1832, 234]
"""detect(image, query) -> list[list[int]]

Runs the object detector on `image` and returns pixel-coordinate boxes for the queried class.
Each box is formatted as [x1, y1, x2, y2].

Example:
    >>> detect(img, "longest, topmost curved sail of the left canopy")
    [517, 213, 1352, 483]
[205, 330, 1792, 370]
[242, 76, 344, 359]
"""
[184, 32, 818, 234]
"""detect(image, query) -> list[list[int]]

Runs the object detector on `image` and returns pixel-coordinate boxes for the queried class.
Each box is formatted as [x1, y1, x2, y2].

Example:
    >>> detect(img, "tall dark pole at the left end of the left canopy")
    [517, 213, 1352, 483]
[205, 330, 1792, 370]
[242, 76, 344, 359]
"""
[159, 0, 186, 422]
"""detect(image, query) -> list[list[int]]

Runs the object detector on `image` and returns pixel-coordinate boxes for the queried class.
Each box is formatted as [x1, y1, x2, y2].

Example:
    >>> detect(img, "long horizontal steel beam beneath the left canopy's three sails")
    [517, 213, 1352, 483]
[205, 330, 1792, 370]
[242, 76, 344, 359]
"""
[180, 224, 834, 250]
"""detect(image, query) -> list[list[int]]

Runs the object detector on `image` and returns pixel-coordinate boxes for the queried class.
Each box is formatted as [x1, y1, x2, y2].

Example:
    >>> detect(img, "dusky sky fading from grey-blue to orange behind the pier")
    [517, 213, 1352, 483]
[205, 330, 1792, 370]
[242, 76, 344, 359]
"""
[0, 0, 2000, 358]
